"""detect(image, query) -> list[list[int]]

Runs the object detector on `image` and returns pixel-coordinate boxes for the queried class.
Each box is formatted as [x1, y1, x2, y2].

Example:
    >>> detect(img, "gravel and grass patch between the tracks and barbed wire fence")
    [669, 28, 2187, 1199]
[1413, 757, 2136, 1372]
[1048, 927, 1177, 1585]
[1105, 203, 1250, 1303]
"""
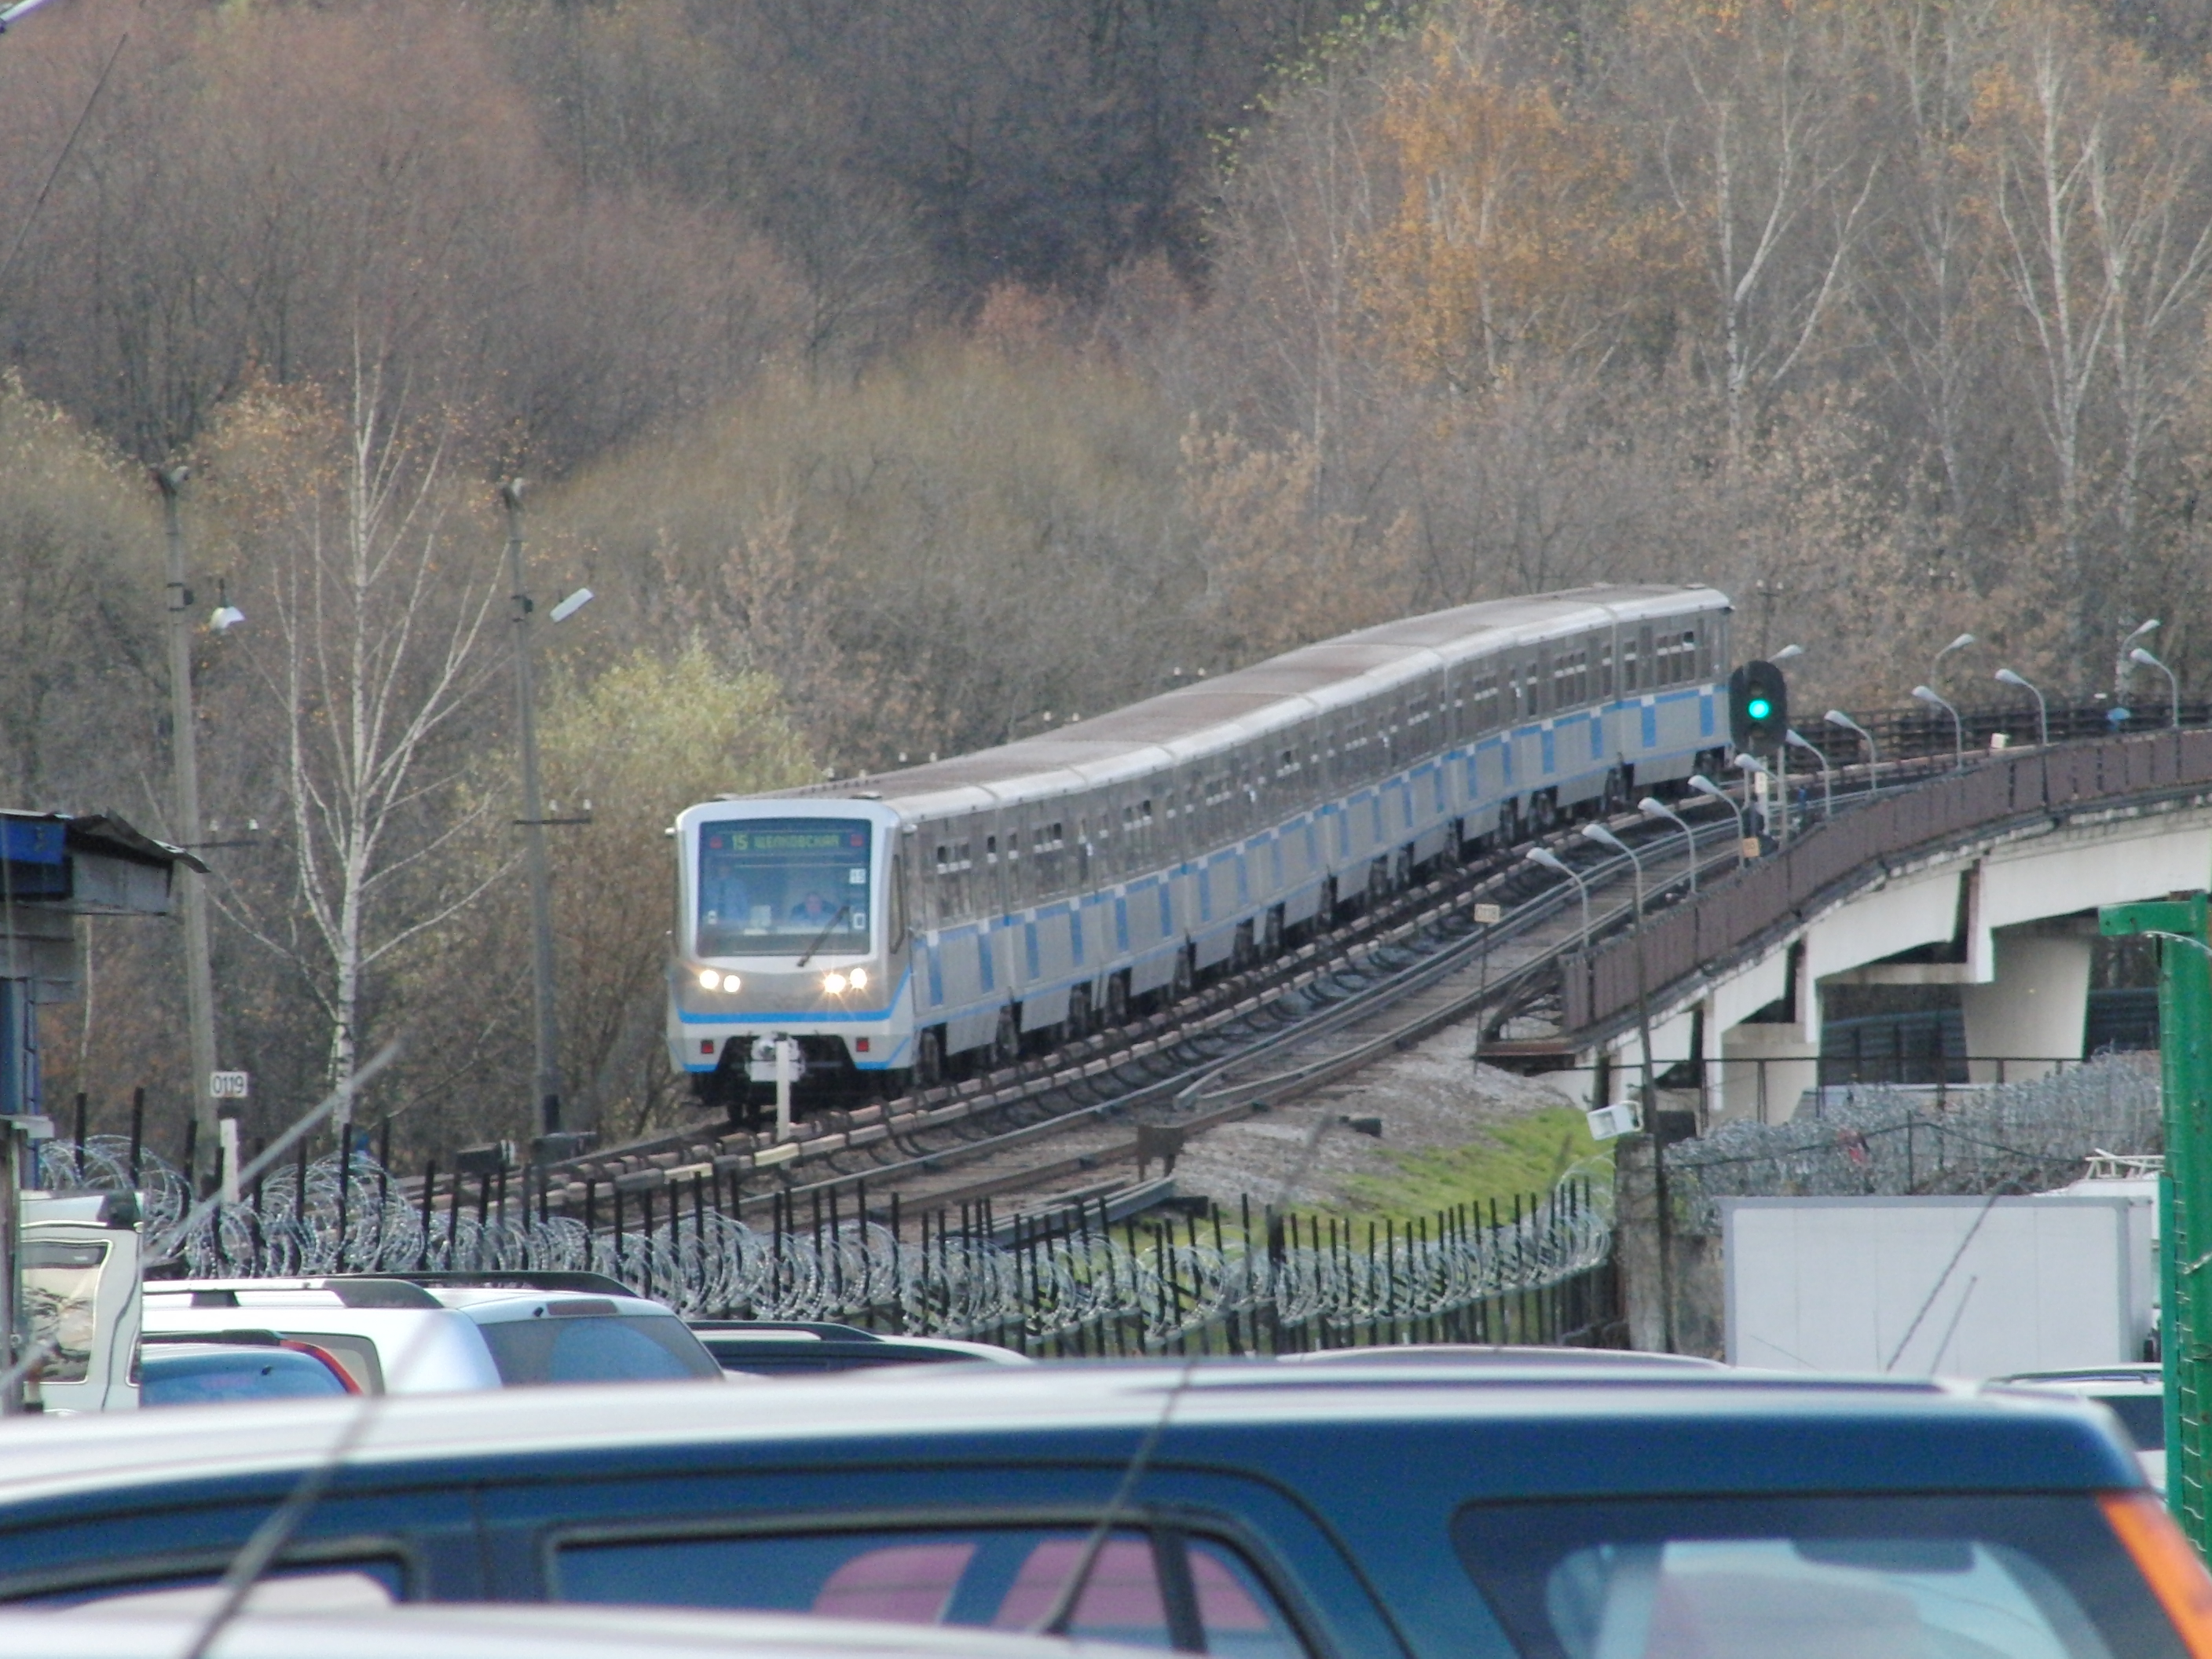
[1174, 1027, 1588, 1206]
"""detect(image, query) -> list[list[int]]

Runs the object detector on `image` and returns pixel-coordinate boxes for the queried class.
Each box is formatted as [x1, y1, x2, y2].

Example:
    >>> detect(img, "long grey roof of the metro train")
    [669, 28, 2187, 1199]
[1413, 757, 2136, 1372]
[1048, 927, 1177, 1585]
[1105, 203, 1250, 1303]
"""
[759, 584, 1727, 819]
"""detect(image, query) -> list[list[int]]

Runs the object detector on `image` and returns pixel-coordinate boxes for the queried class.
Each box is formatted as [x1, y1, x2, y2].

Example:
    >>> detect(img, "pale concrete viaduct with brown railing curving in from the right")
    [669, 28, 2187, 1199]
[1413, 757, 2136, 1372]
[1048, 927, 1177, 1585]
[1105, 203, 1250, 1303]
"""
[1548, 730, 2212, 1124]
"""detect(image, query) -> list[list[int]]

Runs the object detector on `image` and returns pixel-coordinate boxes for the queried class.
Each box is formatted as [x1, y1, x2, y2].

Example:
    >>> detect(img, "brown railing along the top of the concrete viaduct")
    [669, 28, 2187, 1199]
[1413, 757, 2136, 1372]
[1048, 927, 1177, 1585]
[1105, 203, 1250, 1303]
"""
[1559, 730, 2212, 1031]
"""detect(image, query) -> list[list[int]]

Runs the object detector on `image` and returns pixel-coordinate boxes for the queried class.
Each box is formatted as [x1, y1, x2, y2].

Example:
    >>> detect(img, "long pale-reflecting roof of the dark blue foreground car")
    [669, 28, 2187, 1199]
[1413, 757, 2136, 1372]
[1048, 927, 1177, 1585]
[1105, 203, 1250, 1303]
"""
[0, 1361, 2141, 1507]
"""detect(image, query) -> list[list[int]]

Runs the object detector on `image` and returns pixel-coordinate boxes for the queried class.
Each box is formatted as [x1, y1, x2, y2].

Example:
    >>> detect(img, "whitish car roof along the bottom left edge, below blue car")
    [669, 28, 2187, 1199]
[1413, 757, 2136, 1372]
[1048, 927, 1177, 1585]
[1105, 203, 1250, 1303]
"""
[0, 1610, 1157, 1659]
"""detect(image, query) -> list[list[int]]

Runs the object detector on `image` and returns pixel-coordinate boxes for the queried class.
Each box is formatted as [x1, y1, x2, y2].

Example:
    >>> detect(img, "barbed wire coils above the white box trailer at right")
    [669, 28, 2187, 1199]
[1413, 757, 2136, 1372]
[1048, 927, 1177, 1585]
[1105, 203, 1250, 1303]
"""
[1664, 1053, 2166, 1234]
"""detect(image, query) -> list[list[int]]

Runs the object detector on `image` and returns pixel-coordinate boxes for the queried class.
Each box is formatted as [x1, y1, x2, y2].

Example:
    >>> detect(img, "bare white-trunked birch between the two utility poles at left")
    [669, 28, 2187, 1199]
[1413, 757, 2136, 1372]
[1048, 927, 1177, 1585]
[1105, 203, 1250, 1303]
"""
[212, 367, 504, 1110]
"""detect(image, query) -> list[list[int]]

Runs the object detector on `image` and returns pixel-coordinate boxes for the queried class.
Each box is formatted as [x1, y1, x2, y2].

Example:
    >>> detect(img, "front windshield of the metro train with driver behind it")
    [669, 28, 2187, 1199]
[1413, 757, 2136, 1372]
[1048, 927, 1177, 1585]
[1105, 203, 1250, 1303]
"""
[697, 819, 873, 956]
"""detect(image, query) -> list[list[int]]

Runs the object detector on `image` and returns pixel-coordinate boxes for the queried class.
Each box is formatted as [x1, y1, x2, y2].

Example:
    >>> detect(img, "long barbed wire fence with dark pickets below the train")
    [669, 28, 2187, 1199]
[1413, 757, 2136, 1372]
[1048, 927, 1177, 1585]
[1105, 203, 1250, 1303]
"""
[40, 1135, 1617, 1353]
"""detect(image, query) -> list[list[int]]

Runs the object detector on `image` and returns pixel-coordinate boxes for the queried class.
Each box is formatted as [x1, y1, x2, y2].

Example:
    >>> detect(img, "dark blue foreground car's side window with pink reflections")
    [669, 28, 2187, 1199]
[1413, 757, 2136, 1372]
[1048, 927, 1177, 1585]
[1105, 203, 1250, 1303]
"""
[558, 1526, 1305, 1659]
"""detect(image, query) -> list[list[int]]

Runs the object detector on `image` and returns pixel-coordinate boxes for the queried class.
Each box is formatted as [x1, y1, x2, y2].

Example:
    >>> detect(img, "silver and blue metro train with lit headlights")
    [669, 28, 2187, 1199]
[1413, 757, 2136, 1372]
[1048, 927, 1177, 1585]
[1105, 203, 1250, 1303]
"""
[668, 586, 1730, 1112]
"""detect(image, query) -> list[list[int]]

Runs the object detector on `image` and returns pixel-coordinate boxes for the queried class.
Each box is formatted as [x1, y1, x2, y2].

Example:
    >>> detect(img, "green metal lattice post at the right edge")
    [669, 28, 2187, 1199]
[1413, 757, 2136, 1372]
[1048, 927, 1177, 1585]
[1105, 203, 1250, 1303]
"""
[2097, 894, 2212, 1555]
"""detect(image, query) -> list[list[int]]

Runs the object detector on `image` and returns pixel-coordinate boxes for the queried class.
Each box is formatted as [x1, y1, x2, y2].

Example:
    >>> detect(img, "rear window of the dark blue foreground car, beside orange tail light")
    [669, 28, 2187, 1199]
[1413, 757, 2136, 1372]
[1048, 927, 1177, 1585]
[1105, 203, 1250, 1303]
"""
[1453, 1496, 2183, 1659]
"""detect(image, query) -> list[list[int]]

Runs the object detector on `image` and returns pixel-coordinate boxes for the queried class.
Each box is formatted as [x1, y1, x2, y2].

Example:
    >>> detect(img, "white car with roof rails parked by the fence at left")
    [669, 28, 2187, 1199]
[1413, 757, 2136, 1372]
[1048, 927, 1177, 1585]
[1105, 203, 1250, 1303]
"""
[144, 1272, 723, 1393]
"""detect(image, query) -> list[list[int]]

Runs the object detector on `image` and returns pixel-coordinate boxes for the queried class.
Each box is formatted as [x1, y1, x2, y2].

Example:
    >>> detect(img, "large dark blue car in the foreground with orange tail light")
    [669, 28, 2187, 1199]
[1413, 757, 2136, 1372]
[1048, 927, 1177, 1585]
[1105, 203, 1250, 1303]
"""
[0, 1361, 2212, 1659]
